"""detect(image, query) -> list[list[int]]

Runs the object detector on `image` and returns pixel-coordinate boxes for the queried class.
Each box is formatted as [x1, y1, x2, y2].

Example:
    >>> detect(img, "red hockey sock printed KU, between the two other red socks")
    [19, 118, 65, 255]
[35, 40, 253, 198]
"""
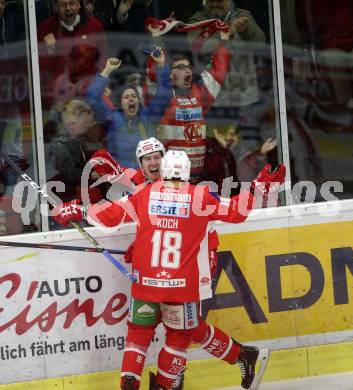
[156, 345, 186, 389]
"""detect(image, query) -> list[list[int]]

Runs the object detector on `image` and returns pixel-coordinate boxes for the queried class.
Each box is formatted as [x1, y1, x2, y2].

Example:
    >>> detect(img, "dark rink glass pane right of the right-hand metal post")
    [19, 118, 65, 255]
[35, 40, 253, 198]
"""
[281, 0, 353, 202]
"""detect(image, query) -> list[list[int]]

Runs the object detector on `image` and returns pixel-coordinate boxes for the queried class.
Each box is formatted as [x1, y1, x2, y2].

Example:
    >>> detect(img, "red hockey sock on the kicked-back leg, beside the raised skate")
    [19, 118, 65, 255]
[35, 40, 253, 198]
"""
[201, 325, 241, 364]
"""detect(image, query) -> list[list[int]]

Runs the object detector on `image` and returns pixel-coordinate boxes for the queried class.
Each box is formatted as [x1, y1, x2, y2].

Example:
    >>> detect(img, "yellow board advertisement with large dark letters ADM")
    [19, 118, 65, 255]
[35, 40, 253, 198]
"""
[206, 222, 353, 349]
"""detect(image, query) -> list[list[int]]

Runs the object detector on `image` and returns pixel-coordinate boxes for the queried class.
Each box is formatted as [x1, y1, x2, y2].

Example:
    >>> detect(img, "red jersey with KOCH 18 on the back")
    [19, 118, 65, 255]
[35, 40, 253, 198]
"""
[87, 181, 253, 302]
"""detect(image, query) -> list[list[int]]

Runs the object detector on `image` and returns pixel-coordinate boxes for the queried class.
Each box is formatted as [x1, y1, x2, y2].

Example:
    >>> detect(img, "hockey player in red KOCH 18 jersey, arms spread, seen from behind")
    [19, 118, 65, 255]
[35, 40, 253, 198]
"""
[55, 151, 285, 389]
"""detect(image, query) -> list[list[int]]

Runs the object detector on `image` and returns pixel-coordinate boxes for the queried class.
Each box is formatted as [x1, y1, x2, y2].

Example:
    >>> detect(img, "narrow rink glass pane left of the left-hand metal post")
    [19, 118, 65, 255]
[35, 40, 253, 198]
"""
[0, 0, 40, 235]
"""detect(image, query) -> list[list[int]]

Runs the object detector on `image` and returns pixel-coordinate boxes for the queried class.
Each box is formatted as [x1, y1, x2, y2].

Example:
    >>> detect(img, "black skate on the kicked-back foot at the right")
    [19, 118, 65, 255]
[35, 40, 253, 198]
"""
[236, 345, 269, 390]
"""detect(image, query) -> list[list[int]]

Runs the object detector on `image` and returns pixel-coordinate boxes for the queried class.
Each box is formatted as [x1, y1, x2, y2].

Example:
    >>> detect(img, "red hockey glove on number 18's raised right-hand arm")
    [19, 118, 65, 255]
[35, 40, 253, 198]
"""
[250, 164, 286, 199]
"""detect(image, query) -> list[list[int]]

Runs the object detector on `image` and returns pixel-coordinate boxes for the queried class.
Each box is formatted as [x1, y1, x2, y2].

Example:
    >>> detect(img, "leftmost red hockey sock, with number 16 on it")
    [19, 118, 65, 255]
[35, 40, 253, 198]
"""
[121, 342, 147, 389]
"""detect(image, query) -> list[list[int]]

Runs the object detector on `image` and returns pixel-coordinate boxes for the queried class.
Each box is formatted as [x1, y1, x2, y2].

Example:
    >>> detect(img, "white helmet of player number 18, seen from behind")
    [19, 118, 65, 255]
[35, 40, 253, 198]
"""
[161, 150, 191, 181]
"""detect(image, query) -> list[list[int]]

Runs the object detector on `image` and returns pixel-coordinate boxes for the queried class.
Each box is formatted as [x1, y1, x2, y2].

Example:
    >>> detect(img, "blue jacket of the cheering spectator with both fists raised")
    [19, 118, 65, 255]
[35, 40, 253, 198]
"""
[86, 65, 171, 168]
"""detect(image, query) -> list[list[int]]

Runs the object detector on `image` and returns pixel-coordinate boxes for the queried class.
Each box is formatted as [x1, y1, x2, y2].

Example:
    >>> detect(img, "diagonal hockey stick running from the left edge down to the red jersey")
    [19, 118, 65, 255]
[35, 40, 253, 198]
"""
[0, 152, 137, 283]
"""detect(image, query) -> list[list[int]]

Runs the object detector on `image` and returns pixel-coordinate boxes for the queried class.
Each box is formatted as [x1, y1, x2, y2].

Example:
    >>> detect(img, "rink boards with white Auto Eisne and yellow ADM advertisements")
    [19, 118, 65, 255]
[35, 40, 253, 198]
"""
[0, 216, 353, 389]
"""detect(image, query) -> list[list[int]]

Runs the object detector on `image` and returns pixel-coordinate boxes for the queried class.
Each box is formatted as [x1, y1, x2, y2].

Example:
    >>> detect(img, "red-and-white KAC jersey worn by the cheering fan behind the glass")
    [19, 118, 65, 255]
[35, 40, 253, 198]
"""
[147, 45, 231, 176]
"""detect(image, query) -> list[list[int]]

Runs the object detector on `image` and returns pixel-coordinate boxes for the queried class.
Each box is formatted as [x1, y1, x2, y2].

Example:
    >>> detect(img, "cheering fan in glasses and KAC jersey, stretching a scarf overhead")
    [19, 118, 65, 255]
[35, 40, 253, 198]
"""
[144, 18, 232, 184]
